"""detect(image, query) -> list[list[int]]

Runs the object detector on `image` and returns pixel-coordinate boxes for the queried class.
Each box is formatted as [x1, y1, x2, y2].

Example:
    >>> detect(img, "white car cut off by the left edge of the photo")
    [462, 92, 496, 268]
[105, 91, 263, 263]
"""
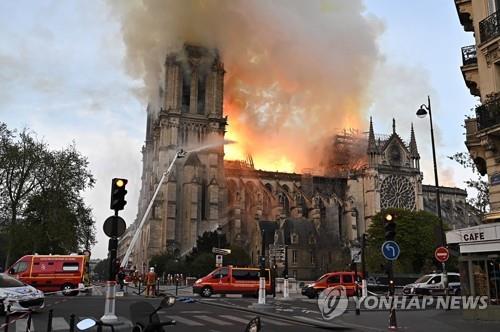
[0, 273, 45, 314]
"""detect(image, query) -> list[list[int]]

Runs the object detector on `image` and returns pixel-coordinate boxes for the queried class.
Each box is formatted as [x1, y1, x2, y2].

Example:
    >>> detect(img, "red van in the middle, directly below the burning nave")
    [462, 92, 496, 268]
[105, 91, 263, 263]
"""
[193, 266, 271, 297]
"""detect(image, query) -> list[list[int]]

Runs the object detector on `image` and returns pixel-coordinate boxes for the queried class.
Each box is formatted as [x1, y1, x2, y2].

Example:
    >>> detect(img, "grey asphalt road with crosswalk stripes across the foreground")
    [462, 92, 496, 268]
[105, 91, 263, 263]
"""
[0, 292, 500, 332]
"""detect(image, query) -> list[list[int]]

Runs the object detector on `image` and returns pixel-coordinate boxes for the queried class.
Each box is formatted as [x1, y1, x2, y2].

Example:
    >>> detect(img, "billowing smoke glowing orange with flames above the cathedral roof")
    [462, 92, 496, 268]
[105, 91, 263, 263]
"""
[112, 0, 382, 170]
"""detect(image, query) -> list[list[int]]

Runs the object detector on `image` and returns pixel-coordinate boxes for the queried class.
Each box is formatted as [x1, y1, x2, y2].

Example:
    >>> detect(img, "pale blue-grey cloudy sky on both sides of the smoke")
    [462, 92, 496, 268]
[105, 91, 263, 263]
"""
[0, 0, 478, 257]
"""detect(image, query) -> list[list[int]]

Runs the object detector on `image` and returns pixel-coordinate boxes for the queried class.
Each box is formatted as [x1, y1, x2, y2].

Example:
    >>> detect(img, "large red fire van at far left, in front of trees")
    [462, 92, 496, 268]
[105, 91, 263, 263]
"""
[7, 255, 88, 295]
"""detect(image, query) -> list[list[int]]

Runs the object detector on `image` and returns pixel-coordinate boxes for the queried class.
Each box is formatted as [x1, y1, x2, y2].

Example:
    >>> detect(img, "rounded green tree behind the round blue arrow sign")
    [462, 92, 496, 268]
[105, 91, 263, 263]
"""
[366, 209, 440, 273]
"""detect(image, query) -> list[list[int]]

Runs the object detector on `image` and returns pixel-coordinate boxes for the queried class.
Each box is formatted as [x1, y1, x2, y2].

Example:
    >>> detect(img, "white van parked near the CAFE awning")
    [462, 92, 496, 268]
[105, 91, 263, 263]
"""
[403, 272, 460, 296]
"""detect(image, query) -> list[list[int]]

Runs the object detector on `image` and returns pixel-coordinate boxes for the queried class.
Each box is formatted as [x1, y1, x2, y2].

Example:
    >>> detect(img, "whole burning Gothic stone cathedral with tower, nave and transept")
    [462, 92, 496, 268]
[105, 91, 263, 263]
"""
[119, 45, 476, 279]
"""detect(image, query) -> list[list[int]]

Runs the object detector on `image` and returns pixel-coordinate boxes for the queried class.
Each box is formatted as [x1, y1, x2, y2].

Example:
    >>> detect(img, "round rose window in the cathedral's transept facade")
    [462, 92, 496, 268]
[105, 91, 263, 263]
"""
[380, 175, 415, 210]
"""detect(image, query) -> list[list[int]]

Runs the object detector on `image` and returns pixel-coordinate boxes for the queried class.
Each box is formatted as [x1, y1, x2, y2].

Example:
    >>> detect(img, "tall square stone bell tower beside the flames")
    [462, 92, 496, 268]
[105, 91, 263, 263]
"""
[143, 44, 227, 254]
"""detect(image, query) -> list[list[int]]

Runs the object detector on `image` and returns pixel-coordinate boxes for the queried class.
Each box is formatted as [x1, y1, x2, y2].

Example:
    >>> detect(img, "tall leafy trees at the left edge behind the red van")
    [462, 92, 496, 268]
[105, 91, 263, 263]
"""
[0, 123, 95, 267]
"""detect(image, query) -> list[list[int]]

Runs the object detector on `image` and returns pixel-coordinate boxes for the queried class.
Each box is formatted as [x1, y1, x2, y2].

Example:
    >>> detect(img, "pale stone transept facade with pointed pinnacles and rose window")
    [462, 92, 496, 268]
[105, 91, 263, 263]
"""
[344, 118, 424, 240]
